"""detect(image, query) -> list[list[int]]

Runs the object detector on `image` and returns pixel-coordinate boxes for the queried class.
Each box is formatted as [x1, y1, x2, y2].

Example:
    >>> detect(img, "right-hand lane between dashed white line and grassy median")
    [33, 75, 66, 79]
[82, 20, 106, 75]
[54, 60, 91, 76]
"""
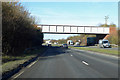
[69, 50, 118, 78]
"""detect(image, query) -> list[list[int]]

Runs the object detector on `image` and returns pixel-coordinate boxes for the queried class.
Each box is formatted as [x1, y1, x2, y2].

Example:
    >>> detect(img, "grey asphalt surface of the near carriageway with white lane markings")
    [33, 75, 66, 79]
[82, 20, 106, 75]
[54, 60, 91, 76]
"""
[13, 47, 118, 78]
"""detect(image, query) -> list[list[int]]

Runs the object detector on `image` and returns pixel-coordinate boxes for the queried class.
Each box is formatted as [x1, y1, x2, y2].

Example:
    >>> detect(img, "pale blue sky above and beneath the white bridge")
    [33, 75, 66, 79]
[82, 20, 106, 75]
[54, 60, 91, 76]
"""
[22, 2, 118, 39]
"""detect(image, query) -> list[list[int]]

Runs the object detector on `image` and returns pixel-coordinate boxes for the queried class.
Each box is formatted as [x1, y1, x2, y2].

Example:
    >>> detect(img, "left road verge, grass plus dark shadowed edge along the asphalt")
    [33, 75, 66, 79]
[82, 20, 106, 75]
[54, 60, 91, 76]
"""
[2, 47, 47, 80]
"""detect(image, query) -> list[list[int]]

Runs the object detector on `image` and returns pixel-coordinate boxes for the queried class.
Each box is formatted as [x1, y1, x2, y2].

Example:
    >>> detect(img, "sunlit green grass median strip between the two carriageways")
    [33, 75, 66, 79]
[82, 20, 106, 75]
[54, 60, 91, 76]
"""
[69, 46, 119, 55]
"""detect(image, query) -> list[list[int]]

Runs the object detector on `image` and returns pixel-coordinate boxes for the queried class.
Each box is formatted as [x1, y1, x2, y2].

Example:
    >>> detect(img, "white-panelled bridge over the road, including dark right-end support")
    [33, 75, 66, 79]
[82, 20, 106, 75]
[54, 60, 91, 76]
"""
[37, 25, 110, 43]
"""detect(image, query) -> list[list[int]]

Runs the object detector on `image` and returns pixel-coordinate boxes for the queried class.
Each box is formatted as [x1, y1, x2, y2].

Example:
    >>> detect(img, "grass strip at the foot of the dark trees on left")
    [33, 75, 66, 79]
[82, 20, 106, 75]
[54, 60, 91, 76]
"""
[0, 48, 45, 73]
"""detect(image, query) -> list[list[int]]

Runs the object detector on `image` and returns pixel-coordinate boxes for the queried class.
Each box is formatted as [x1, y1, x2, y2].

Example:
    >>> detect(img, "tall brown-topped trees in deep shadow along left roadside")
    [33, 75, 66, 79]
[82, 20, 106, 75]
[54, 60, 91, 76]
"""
[2, 2, 43, 56]
